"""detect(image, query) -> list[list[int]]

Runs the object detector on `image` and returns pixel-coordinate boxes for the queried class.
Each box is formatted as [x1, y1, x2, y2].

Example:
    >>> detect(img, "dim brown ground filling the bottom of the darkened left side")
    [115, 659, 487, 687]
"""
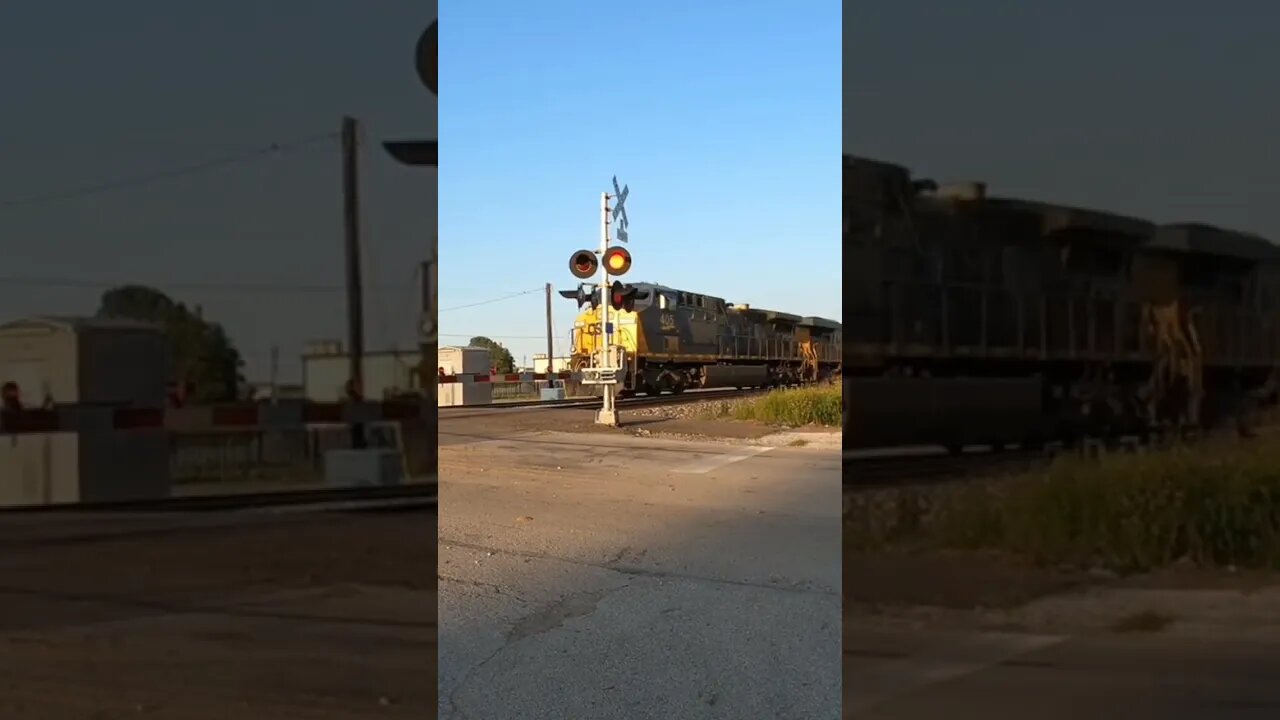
[0, 511, 436, 720]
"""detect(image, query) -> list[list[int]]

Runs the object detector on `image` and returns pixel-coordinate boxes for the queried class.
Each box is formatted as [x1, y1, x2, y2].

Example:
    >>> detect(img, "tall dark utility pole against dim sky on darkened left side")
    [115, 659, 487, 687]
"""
[342, 117, 366, 448]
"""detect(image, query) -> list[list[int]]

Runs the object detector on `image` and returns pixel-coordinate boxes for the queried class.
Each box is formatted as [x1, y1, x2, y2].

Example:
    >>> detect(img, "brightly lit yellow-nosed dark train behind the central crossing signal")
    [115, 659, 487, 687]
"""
[560, 283, 841, 395]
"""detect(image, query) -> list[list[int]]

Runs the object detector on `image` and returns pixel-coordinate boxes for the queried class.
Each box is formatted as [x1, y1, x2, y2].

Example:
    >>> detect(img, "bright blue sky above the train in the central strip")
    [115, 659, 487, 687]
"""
[439, 0, 841, 363]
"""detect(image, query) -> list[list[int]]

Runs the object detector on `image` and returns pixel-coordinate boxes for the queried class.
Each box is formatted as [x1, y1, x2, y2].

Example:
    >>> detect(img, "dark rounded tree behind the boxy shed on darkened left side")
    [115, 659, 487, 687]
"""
[97, 284, 244, 402]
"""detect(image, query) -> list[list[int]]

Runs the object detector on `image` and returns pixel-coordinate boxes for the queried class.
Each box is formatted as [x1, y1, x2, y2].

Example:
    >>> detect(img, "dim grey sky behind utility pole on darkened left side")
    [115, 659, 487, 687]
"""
[0, 0, 436, 379]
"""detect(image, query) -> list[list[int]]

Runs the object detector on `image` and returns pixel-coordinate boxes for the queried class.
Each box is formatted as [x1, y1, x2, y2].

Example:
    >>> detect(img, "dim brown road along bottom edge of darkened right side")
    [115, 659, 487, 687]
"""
[845, 629, 1280, 720]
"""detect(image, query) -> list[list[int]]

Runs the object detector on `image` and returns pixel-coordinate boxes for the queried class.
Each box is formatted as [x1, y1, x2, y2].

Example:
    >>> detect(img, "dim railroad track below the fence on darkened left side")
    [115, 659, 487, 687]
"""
[0, 482, 438, 515]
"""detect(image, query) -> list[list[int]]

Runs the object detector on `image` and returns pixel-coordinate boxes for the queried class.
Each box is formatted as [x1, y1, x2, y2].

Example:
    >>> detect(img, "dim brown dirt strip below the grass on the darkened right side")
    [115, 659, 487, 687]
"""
[842, 538, 1280, 638]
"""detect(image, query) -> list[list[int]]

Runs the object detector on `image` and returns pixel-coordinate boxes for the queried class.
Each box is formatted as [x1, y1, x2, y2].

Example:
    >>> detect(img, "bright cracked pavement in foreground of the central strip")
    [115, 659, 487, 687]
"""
[438, 427, 841, 720]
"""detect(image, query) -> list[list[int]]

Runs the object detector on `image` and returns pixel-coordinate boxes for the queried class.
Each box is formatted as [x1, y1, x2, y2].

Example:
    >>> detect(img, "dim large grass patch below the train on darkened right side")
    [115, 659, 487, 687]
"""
[928, 443, 1280, 573]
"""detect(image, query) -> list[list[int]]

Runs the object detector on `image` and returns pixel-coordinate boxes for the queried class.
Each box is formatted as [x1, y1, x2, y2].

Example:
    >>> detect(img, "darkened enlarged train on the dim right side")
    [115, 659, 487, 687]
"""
[842, 155, 1280, 450]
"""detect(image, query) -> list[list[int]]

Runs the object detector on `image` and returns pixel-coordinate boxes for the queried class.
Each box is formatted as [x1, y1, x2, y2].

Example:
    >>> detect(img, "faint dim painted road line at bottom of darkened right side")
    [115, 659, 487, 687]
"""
[844, 633, 1066, 717]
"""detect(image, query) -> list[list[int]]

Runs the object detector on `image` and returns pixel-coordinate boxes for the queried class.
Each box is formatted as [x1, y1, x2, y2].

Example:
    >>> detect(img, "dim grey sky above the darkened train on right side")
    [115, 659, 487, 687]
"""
[844, 0, 1280, 238]
